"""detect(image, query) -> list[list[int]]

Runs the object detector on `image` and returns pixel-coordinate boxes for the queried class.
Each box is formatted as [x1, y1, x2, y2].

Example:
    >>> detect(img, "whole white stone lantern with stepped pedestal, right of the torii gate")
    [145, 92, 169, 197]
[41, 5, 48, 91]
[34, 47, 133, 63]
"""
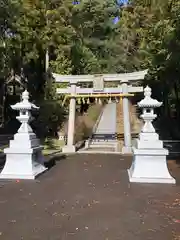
[128, 86, 175, 183]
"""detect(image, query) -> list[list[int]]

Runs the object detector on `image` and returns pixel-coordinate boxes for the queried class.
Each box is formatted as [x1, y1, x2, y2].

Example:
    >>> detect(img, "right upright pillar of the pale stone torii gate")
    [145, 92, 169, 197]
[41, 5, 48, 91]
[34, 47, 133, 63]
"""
[122, 81, 132, 153]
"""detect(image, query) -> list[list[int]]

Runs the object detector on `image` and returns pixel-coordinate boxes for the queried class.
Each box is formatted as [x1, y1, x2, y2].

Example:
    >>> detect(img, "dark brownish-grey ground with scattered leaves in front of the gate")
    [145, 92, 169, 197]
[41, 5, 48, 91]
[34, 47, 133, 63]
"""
[0, 154, 180, 240]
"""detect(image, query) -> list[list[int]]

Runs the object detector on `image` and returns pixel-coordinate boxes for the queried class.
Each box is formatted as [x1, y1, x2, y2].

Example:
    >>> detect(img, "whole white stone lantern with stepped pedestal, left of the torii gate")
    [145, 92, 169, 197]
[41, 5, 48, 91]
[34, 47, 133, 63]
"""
[0, 90, 46, 179]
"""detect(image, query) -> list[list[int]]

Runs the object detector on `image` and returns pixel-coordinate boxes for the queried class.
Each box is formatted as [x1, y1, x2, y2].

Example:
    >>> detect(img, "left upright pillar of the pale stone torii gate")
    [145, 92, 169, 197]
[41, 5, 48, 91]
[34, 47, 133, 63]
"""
[62, 82, 76, 153]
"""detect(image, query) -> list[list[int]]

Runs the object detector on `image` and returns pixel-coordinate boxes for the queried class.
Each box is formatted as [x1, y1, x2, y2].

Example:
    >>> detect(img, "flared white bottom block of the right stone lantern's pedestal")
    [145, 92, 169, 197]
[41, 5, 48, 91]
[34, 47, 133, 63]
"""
[128, 147, 176, 184]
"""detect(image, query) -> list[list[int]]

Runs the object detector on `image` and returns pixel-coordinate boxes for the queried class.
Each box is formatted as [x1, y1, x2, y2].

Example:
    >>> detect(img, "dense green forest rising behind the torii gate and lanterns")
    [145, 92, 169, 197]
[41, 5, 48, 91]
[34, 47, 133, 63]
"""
[0, 0, 180, 138]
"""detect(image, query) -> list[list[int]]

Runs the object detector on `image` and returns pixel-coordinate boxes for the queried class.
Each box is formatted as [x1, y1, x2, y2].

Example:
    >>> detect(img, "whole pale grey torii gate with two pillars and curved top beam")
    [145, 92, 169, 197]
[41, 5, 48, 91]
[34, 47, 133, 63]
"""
[52, 70, 147, 153]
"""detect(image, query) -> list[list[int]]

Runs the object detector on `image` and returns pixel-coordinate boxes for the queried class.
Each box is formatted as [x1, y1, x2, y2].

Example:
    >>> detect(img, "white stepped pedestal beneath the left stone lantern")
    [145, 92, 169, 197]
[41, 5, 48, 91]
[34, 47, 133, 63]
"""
[0, 133, 47, 179]
